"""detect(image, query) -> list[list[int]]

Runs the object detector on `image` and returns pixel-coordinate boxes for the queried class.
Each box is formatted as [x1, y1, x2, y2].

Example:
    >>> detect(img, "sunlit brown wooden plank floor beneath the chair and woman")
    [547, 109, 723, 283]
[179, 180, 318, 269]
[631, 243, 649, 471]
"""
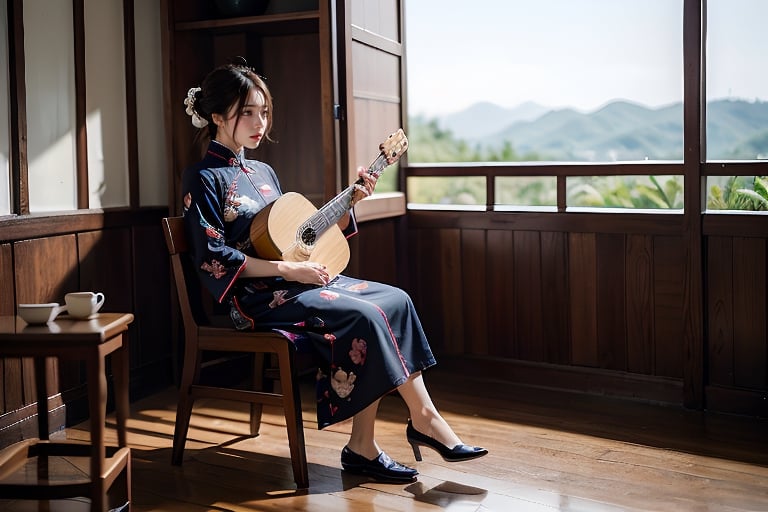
[0, 368, 768, 512]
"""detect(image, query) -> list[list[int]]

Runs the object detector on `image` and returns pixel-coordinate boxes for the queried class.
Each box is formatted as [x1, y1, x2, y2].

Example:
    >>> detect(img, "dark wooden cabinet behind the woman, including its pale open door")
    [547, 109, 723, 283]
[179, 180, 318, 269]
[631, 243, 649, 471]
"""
[163, 0, 402, 216]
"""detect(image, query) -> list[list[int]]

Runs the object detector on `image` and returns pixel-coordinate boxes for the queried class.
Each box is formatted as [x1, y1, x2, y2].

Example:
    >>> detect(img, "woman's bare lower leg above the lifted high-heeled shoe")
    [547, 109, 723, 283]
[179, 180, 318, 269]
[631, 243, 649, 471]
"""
[397, 372, 462, 447]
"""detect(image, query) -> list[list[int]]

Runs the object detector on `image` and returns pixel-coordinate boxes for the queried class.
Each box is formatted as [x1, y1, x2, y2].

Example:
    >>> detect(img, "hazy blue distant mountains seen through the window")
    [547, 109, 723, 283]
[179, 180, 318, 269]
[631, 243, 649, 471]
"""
[428, 100, 768, 161]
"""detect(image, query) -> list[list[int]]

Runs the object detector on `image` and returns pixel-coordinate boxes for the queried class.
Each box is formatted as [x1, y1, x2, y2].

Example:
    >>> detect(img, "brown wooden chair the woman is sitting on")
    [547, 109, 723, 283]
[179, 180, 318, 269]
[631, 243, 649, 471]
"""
[162, 217, 309, 489]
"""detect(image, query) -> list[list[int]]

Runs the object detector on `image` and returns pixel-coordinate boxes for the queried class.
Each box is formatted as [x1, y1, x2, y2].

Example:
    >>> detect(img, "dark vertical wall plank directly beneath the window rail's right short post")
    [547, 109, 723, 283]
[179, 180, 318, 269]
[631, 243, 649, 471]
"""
[541, 231, 571, 364]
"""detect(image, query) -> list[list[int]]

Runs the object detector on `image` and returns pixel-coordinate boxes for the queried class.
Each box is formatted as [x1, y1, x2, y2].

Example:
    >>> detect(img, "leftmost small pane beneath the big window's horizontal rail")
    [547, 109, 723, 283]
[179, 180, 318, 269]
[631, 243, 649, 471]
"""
[408, 176, 486, 210]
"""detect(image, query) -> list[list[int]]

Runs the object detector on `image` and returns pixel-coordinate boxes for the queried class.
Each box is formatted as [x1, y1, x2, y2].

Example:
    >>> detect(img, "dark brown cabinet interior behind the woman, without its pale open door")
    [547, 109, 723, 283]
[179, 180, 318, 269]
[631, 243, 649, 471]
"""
[163, 0, 338, 212]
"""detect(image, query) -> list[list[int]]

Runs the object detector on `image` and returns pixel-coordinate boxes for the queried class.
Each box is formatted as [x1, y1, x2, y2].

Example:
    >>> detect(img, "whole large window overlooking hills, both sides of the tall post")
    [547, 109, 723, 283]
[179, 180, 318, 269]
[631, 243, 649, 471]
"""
[405, 0, 768, 212]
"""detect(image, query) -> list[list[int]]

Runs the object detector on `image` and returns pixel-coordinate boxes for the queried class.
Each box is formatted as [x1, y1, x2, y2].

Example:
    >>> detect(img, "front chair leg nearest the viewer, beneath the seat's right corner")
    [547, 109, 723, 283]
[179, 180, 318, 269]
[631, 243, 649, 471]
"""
[277, 344, 309, 489]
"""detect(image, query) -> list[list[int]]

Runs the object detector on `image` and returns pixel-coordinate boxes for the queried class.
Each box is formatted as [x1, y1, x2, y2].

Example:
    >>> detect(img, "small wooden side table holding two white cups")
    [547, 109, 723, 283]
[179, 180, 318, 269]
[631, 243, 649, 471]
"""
[0, 313, 133, 512]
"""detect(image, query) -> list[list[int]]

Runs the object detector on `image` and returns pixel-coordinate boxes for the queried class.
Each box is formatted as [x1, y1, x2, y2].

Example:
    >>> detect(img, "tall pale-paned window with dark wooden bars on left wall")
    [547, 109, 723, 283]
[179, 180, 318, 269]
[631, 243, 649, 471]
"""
[0, 0, 167, 216]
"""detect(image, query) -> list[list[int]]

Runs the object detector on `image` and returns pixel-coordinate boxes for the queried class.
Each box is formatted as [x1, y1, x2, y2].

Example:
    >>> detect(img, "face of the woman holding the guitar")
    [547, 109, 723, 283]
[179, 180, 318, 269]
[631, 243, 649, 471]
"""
[212, 88, 269, 153]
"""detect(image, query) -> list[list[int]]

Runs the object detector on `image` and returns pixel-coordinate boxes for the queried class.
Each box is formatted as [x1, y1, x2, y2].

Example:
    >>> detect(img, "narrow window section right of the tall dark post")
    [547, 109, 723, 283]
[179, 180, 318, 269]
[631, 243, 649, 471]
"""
[705, 0, 768, 211]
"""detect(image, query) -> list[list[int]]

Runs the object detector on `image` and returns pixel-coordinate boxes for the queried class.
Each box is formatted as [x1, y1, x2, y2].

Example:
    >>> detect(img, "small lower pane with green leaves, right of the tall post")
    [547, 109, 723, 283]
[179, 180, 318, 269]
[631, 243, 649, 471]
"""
[707, 176, 768, 212]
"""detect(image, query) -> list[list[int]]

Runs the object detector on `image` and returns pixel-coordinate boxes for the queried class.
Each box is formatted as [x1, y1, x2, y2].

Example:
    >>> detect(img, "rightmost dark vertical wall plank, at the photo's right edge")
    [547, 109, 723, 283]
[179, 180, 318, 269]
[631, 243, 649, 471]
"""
[733, 237, 768, 389]
